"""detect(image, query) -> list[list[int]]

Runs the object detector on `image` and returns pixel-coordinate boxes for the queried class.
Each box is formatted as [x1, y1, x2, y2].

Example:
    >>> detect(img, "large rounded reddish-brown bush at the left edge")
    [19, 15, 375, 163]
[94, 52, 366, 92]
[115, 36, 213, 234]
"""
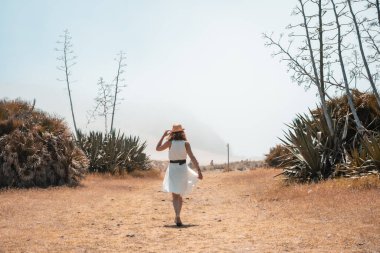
[0, 100, 88, 187]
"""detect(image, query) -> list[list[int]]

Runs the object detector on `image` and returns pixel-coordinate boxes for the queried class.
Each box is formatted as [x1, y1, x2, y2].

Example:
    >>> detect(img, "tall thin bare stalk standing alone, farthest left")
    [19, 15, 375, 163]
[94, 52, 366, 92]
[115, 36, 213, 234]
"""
[55, 29, 78, 137]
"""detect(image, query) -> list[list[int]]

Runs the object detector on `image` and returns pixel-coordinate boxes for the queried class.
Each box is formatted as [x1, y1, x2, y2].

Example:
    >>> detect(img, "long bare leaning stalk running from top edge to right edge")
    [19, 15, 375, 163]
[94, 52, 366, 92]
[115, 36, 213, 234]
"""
[346, 0, 380, 107]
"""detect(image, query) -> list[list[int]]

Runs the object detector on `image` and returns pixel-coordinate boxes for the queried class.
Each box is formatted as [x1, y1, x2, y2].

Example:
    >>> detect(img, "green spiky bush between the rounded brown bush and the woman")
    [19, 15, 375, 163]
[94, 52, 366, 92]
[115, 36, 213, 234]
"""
[78, 131, 149, 174]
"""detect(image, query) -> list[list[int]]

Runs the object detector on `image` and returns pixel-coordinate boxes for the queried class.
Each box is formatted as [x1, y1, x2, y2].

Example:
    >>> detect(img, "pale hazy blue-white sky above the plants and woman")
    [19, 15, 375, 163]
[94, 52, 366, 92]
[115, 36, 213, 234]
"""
[0, 0, 317, 164]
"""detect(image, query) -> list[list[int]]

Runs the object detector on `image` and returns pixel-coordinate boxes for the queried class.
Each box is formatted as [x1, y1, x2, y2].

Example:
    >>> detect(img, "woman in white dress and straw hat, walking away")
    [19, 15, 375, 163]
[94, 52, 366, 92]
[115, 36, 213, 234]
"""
[156, 124, 203, 226]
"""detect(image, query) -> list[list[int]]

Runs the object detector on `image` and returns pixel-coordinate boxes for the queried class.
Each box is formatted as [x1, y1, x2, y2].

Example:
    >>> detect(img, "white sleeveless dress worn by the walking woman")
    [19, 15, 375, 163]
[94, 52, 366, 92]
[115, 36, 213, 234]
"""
[162, 141, 198, 195]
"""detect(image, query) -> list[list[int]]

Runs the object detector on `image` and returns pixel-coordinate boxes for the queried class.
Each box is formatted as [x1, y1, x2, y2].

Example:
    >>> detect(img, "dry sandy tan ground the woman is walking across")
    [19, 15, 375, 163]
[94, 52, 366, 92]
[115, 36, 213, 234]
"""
[0, 169, 380, 252]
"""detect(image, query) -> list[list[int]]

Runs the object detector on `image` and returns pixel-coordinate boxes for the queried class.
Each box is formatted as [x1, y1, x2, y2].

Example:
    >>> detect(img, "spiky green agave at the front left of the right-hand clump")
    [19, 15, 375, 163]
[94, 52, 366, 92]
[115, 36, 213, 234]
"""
[282, 106, 347, 182]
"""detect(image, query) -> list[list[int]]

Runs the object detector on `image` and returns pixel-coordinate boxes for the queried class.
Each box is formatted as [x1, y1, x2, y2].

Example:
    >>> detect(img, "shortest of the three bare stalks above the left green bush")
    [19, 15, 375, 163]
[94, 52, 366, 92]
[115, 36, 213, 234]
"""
[87, 77, 113, 134]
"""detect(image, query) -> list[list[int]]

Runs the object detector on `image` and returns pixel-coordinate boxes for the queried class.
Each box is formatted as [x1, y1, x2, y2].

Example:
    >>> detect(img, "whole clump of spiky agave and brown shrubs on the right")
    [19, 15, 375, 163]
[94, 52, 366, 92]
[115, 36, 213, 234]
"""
[276, 91, 380, 182]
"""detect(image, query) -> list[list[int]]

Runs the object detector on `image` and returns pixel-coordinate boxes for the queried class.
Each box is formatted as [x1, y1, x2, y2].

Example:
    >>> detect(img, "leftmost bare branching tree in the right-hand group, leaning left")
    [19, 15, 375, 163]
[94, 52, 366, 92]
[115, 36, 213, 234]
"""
[264, 0, 338, 136]
